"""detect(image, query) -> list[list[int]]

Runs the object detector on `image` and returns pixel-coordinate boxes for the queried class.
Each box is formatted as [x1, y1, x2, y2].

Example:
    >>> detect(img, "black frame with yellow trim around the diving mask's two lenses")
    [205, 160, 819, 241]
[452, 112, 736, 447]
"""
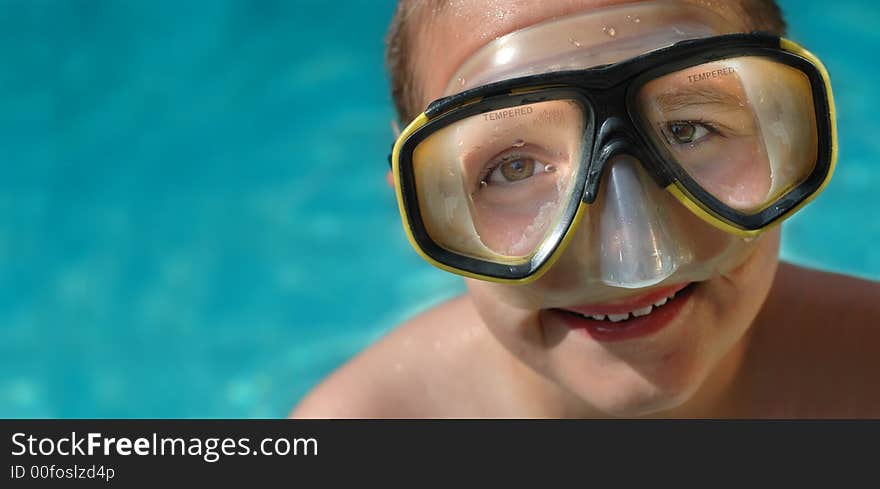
[389, 33, 836, 282]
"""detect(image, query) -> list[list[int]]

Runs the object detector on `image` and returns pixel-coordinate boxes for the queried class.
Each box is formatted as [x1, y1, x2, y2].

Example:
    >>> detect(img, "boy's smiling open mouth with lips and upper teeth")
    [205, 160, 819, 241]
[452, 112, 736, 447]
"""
[550, 282, 698, 342]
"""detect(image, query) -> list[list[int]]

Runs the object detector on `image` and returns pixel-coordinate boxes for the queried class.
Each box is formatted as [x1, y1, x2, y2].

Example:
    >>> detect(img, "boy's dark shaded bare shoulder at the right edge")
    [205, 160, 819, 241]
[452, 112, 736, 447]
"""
[748, 264, 880, 417]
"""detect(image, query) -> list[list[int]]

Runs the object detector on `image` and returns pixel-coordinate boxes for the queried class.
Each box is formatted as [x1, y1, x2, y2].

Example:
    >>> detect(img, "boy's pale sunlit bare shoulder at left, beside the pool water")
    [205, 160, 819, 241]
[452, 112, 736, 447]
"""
[290, 295, 508, 418]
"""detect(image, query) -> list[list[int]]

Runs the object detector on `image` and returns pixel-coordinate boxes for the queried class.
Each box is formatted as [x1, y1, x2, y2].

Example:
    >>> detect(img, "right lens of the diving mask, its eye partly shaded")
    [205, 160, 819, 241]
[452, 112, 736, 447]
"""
[637, 56, 818, 214]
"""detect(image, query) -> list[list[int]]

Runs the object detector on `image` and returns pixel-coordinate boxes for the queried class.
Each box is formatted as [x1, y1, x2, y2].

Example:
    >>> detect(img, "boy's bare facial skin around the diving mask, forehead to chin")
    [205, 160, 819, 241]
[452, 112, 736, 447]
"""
[412, 0, 779, 416]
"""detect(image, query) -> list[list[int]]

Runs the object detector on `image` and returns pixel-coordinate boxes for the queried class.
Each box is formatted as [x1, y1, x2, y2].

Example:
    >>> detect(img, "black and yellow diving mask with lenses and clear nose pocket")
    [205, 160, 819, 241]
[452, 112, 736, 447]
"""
[391, 8, 836, 288]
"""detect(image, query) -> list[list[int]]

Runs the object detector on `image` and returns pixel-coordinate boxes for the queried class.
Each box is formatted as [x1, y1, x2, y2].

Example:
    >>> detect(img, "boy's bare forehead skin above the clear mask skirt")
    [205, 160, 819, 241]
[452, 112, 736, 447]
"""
[409, 0, 746, 106]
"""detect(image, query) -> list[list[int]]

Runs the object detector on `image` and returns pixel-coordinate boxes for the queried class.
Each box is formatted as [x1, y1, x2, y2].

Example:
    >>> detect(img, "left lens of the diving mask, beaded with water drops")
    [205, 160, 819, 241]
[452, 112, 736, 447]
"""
[412, 100, 586, 263]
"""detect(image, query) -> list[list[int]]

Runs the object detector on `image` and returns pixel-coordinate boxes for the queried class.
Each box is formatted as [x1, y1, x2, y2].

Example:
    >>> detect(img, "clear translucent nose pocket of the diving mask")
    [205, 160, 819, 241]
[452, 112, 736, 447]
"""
[592, 155, 686, 289]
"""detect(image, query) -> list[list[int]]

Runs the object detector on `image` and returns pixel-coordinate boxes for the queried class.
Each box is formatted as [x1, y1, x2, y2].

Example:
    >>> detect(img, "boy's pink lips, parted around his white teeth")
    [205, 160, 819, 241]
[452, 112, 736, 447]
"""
[549, 284, 697, 342]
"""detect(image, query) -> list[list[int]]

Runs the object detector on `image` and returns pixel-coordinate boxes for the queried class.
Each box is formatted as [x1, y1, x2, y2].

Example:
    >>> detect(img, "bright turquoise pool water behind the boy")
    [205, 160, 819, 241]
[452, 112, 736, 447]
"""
[0, 0, 880, 417]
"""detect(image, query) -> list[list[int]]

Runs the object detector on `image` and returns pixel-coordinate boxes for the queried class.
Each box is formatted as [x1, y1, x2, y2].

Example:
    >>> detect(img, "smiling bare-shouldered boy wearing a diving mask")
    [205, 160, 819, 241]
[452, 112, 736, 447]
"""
[292, 0, 880, 418]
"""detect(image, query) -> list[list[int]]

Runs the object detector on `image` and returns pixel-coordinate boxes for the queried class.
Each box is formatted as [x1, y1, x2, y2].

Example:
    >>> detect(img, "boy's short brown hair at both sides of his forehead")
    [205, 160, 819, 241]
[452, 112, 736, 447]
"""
[385, 0, 786, 124]
